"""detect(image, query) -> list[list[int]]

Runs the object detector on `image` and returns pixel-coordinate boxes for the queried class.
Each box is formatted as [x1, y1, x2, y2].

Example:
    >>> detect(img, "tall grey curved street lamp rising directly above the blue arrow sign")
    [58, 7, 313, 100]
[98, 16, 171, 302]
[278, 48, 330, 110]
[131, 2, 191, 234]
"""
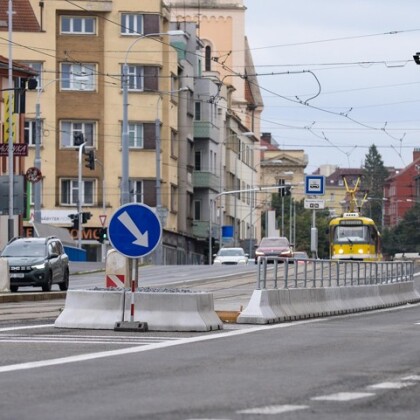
[121, 30, 185, 205]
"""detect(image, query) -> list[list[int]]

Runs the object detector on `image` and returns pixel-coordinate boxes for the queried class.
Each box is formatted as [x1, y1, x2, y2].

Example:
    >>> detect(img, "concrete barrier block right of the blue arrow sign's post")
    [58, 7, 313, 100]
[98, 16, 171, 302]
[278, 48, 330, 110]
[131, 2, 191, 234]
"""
[129, 291, 223, 331]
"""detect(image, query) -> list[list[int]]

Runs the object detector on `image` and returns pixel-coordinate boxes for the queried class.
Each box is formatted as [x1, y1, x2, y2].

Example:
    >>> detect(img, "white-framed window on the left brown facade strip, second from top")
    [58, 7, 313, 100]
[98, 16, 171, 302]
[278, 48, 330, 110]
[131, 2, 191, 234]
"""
[60, 63, 96, 91]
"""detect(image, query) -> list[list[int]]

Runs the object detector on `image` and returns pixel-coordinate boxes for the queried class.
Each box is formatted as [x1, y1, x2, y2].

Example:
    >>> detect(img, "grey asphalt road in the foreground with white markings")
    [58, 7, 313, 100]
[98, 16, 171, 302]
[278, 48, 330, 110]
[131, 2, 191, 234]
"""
[0, 305, 420, 420]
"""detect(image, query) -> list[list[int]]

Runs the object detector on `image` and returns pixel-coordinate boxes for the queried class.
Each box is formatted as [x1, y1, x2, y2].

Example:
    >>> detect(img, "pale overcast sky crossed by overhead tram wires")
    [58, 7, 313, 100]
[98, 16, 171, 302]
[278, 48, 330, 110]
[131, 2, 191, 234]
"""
[244, 0, 420, 173]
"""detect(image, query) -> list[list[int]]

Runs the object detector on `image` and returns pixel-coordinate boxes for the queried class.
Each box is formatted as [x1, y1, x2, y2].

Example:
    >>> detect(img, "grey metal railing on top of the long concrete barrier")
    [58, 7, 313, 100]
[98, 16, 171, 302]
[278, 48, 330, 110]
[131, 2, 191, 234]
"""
[256, 257, 414, 289]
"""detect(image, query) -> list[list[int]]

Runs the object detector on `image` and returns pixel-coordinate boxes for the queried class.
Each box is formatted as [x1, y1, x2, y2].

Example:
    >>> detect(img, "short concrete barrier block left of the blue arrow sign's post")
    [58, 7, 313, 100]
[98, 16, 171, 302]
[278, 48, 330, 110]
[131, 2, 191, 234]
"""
[54, 290, 124, 330]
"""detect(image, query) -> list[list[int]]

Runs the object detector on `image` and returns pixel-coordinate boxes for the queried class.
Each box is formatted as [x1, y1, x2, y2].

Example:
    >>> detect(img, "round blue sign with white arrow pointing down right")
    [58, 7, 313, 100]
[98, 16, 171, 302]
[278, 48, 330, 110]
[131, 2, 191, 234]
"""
[108, 203, 162, 258]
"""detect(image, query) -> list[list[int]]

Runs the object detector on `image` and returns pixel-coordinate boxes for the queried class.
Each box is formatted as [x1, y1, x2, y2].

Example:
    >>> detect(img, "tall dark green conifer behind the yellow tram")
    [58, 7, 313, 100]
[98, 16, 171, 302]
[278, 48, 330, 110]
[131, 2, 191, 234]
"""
[362, 144, 389, 230]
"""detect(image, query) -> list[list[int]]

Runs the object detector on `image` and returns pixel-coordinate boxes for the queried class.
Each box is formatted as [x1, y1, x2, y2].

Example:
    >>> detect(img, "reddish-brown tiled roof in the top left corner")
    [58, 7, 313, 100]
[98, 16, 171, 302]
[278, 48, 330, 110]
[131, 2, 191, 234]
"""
[0, 0, 41, 32]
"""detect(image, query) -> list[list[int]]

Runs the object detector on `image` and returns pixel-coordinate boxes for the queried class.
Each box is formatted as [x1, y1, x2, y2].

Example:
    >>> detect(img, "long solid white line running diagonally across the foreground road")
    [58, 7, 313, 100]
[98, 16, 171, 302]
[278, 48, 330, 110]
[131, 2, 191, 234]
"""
[0, 318, 322, 373]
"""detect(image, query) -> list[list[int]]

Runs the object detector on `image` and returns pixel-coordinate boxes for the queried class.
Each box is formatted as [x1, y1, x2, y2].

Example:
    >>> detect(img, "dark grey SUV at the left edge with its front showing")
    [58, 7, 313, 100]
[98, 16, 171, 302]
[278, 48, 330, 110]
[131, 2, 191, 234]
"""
[1, 236, 69, 292]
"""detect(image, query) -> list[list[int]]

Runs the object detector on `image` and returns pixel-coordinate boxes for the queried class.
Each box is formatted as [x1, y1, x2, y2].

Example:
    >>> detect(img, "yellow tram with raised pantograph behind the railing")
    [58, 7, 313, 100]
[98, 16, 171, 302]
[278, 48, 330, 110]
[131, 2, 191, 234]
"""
[329, 174, 382, 261]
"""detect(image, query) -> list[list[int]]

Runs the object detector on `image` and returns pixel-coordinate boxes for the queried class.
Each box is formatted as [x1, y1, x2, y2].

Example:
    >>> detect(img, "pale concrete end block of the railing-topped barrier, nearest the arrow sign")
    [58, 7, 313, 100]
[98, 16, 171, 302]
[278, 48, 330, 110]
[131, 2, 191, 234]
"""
[236, 289, 279, 324]
